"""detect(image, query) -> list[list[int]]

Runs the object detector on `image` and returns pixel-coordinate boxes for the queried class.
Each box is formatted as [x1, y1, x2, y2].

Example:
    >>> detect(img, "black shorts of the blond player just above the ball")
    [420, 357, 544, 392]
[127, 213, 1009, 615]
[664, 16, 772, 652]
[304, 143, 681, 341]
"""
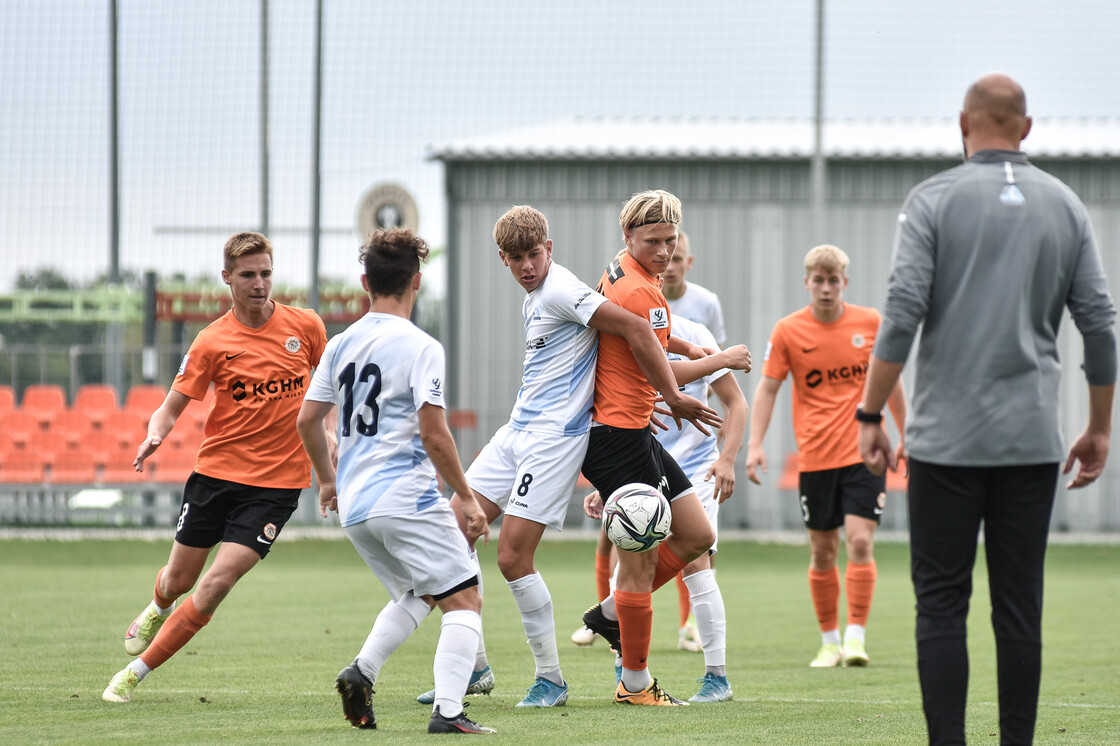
[582, 425, 696, 502]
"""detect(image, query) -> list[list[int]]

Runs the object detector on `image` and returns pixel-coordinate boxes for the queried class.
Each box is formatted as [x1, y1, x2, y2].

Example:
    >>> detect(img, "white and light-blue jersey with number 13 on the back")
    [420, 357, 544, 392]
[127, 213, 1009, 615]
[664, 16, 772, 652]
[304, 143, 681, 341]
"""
[306, 311, 445, 526]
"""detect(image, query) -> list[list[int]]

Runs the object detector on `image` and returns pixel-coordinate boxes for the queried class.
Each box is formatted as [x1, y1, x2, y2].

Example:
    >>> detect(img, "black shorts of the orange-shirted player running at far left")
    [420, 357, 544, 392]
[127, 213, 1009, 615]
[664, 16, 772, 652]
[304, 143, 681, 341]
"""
[175, 472, 300, 559]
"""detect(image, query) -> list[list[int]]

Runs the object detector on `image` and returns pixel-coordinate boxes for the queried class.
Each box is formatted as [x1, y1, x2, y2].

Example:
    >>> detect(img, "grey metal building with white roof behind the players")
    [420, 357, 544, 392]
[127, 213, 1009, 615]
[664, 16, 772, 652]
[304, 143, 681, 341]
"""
[430, 119, 1120, 531]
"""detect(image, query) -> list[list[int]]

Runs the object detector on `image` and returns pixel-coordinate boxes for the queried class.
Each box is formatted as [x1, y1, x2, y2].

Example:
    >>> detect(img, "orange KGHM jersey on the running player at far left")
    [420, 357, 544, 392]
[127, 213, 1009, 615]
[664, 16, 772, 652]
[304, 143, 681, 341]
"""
[171, 304, 327, 489]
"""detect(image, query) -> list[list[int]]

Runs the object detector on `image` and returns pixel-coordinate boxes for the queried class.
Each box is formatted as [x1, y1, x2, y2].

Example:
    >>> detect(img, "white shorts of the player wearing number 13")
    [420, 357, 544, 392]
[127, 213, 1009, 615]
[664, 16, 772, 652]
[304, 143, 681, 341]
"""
[343, 500, 478, 600]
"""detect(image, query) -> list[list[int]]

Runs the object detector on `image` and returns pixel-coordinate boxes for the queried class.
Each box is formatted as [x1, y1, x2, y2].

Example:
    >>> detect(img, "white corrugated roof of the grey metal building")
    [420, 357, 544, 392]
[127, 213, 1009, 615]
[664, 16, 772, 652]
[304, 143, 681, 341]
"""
[428, 116, 1120, 161]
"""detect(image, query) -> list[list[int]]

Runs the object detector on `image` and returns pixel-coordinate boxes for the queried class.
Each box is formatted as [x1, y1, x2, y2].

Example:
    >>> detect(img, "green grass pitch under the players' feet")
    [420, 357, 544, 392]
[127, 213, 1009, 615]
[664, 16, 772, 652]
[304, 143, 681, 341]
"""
[0, 530, 1120, 746]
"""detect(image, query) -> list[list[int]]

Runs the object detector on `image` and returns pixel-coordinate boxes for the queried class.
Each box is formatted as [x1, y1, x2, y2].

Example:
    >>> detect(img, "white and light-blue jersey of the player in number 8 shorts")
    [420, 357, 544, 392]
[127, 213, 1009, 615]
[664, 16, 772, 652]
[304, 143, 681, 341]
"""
[510, 262, 607, 436]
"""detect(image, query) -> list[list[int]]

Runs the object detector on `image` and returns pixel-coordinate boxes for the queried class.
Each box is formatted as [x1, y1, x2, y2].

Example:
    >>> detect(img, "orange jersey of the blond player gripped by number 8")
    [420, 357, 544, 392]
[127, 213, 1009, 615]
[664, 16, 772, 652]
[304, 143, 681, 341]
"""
[592, 253, 670, 430]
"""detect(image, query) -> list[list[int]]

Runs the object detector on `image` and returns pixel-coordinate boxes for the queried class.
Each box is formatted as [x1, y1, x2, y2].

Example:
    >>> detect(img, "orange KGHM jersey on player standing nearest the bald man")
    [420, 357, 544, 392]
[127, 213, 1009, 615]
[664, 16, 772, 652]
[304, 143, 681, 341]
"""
[763, 304, 880, 472]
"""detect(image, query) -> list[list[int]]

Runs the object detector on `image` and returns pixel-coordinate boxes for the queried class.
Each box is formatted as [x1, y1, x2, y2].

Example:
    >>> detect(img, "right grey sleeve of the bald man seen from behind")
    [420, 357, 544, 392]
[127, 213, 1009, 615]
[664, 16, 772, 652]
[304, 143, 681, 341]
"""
[1066, 207, 1117, 385]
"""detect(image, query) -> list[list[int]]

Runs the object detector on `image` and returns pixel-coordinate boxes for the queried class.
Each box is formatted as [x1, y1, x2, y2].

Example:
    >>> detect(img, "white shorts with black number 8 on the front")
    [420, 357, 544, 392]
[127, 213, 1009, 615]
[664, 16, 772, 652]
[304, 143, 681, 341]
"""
[467, 423, 588, 531]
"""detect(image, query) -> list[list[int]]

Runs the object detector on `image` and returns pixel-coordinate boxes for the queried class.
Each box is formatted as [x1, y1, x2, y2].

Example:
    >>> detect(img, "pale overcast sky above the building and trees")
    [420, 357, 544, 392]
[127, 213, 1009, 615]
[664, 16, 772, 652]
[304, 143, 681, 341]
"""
[0, 0, 1120, 290]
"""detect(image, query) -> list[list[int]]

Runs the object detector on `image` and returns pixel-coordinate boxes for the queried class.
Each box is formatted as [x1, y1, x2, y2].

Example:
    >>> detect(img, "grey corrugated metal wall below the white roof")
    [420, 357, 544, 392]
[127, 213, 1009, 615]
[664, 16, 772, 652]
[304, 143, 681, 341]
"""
[445, 160, 1120, 531]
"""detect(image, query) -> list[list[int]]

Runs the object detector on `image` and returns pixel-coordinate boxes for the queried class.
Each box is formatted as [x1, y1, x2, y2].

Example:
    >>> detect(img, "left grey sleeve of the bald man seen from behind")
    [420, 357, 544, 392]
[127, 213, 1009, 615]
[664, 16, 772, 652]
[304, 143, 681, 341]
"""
[875, 183, 937, 363]
